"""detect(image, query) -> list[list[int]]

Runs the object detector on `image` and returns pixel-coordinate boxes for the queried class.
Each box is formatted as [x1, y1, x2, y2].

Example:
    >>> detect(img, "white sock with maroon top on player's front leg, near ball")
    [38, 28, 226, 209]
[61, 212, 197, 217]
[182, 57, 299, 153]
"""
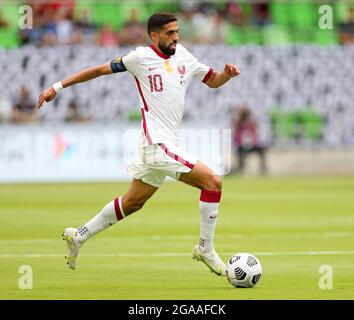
[199, 190, 221, 252]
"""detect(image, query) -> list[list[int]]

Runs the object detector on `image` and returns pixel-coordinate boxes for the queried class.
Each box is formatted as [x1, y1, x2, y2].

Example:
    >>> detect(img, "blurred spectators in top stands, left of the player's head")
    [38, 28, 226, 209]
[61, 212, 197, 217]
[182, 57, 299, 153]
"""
[20, 0, 148, 47]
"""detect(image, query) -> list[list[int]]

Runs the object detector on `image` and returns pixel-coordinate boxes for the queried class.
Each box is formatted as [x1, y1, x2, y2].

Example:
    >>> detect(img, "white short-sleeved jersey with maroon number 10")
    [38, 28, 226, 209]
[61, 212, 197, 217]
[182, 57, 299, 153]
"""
[122, 44, 213, 146]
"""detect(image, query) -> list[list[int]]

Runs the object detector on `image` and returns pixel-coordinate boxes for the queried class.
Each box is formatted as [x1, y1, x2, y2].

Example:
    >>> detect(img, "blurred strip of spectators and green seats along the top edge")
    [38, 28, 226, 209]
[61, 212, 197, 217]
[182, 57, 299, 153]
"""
[0, 0, 354, 47]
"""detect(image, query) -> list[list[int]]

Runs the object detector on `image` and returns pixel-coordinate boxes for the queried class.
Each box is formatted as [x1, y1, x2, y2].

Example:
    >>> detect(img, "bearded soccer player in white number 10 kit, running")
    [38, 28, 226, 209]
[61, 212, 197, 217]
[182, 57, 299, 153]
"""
[38, 12, 240, 275]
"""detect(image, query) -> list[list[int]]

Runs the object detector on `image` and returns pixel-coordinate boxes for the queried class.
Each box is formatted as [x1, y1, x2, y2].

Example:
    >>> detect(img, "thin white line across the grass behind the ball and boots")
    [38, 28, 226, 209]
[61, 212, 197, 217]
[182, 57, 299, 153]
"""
[0, 251, 354, 258]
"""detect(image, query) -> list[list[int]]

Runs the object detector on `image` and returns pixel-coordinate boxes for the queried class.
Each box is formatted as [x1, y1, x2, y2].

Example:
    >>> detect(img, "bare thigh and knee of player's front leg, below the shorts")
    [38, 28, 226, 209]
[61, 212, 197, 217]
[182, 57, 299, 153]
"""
[179, 161, 222, 191]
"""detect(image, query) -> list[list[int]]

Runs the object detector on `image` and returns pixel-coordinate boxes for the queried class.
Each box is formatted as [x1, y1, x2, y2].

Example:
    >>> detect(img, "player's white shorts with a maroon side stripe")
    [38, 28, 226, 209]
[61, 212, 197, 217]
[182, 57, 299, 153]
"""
[127, 143, 198, 188]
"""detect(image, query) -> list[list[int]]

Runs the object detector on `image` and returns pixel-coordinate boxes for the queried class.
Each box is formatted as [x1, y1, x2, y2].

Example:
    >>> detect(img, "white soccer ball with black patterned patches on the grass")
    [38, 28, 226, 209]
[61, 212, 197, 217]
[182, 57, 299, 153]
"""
[226, 253, 262, 288]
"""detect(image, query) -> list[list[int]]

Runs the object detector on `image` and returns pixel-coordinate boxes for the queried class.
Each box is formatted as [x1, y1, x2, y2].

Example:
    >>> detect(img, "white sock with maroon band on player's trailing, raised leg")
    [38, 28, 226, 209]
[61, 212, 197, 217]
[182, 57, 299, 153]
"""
[76, 197, 125, 242]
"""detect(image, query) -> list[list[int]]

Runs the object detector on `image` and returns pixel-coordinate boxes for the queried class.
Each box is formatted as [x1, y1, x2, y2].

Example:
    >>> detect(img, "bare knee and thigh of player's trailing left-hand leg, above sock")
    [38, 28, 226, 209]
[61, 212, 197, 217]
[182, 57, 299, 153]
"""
[122, 179, 158, 212]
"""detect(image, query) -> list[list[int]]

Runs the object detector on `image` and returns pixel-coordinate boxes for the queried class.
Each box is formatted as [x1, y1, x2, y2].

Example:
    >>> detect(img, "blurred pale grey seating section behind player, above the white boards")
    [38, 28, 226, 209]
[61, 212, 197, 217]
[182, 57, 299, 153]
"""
[0, 44, 354, 145]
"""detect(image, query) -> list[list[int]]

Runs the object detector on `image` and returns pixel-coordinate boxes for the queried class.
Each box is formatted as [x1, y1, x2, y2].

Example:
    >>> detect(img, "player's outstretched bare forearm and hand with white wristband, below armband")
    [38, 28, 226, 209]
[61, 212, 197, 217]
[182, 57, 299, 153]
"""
[37, 62, 113, 109]
